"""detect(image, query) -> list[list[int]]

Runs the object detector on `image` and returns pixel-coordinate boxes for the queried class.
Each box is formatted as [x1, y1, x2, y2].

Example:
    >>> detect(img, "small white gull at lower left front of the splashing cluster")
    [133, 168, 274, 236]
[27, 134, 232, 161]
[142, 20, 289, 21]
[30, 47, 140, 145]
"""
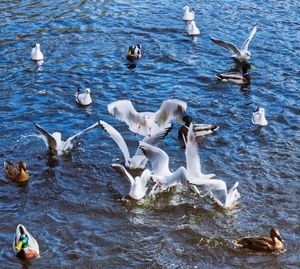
[111, 164, 151, 200]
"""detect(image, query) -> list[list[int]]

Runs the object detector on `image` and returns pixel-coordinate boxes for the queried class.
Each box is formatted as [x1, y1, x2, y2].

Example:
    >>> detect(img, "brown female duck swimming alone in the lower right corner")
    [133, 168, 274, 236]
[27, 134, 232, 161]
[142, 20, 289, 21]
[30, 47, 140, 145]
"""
[236, 228, 283, 252]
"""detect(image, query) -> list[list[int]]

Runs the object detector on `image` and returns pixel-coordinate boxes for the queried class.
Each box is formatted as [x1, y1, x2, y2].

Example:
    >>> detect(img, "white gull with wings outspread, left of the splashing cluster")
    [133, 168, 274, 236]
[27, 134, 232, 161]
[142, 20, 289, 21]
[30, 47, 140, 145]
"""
[35, 122, 98, 155]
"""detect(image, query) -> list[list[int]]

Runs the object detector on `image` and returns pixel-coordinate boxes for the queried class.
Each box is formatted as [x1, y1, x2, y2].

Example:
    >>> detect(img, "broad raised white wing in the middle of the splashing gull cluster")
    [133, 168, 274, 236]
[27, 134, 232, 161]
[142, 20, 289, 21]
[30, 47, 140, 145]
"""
[140, 141, 171, 176]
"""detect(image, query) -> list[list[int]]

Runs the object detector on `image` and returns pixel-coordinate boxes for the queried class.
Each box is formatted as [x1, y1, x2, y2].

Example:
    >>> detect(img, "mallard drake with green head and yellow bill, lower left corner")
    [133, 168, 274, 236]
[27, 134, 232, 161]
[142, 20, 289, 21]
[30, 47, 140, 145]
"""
[12, 224, 40, 260]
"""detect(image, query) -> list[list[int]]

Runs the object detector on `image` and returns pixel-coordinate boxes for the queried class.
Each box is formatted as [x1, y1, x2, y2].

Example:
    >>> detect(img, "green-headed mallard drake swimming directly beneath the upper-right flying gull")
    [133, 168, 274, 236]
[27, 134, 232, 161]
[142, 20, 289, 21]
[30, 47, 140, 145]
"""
[216, 62, 255, 85]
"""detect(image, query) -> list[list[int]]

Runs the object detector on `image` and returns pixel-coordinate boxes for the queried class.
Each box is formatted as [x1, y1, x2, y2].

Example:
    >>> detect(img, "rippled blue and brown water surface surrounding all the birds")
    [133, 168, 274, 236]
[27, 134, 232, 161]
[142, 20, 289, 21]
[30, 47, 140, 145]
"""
[0, 0, 300, 268]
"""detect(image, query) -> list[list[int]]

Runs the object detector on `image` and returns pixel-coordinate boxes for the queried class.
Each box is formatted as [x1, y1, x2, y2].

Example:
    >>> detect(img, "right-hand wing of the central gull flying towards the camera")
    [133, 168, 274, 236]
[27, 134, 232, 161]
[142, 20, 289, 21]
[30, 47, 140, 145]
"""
[155, 99, 187, 126]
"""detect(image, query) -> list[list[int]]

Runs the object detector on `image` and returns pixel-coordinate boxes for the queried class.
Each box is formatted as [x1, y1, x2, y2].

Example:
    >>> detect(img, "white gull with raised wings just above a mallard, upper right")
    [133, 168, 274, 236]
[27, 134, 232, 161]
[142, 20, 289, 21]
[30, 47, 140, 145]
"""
[210, 25, 257, 61]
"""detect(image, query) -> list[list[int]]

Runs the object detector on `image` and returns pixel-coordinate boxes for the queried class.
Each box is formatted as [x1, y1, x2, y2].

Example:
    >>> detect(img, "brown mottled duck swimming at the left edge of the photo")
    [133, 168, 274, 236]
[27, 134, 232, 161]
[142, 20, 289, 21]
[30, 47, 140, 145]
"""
[4, 161, 29, 182]
